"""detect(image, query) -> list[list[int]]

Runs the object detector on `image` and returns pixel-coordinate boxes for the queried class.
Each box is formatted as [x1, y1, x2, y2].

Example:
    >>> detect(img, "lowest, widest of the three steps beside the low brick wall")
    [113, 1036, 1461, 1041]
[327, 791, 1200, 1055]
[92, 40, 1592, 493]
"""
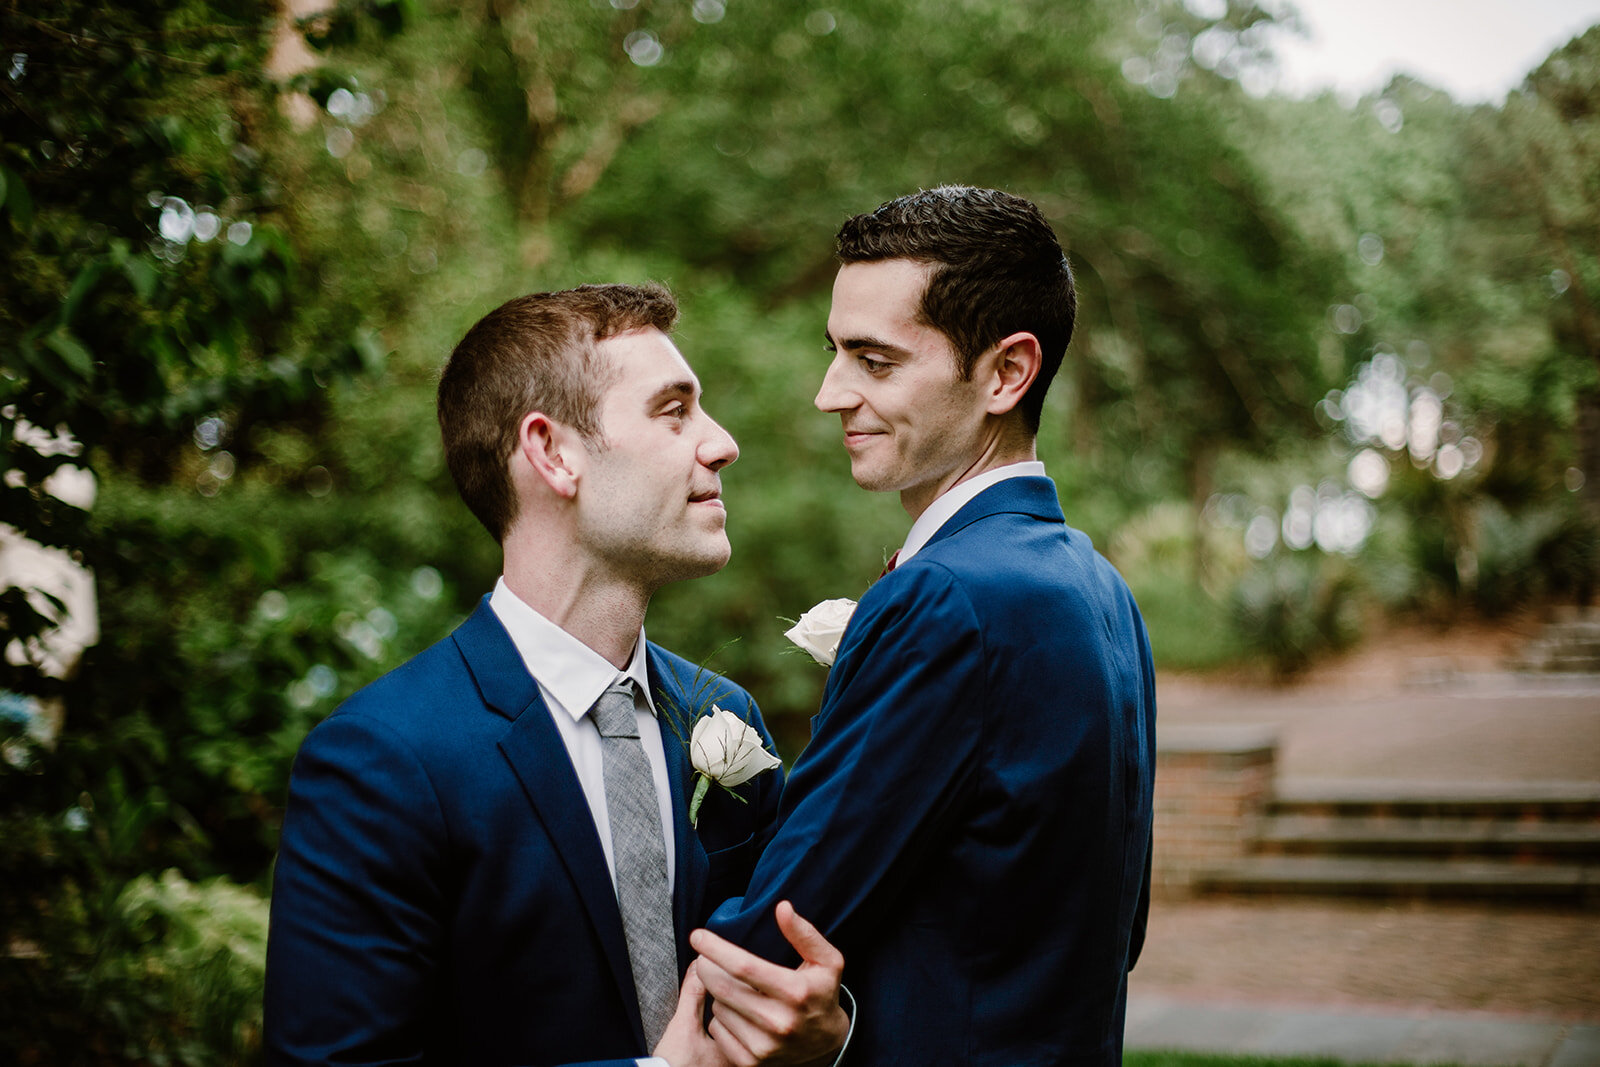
[1195, 856, 1600, 907]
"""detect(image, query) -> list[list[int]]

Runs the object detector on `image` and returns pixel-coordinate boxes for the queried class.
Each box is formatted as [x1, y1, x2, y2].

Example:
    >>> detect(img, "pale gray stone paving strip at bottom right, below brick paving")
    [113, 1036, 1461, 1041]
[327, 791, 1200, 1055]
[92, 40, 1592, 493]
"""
[1126, 995, 1600, 1067]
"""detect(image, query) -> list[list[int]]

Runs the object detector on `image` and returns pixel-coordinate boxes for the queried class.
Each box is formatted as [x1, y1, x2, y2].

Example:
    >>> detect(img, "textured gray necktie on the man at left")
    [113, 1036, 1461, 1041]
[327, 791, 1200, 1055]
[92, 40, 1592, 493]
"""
[590, 678, 678, 1048]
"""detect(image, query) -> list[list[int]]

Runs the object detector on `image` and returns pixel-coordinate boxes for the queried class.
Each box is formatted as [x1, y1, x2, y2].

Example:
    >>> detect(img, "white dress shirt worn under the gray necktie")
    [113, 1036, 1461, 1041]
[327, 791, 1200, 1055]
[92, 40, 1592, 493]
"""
[490, 577, 677, 893]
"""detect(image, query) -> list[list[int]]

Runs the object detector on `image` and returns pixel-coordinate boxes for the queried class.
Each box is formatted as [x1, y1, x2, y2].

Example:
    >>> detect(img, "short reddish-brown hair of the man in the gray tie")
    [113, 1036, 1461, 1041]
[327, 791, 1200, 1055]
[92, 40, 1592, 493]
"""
[438, 285, 678, 542]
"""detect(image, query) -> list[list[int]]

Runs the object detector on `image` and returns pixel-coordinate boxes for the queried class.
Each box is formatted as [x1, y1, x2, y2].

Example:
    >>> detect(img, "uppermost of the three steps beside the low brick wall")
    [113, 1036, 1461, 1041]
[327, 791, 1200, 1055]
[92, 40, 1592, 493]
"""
[1266, 779, 1600, 824]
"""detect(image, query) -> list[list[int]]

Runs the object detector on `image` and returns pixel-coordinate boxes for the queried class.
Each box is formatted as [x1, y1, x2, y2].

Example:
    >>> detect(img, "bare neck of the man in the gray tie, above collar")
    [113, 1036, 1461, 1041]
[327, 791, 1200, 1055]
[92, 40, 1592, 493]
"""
[504, 531, 650, 670]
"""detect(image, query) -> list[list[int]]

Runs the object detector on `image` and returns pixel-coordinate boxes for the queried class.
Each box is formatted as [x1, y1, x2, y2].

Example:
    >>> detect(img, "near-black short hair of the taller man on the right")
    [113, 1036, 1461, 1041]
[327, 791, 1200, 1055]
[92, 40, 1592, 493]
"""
[837, 186, 1078, 434]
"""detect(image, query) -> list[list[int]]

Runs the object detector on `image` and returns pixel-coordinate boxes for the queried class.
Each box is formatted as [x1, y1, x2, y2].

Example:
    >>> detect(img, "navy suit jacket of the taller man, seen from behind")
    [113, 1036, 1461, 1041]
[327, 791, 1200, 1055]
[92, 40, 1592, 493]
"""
[710, 477, 1155, 1067]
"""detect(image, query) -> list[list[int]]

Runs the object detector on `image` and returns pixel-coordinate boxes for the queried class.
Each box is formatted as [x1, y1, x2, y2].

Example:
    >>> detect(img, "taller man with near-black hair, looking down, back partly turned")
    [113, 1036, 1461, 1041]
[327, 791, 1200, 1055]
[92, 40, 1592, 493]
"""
[696, 194, 1155, 1067]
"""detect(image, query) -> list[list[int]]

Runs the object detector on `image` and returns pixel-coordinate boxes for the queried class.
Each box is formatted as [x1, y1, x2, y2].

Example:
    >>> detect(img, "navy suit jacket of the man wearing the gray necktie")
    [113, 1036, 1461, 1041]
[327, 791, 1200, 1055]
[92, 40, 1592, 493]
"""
[264, 597, 782, 1065]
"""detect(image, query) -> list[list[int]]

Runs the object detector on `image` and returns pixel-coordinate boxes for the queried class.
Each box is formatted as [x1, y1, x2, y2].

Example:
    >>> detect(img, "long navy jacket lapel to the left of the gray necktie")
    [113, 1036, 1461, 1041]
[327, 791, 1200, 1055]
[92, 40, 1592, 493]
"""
[453, 597, 646, 1048]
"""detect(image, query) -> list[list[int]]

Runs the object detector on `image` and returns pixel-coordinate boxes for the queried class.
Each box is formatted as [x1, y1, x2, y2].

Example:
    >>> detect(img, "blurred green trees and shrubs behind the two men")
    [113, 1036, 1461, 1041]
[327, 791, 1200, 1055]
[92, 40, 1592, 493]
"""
[0, 0, 1600, 1064]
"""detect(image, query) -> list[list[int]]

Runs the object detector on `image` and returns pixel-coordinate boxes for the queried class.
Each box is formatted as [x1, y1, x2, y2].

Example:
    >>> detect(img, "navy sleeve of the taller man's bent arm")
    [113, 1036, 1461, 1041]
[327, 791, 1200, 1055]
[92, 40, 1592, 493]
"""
[709, 565, 986, 965]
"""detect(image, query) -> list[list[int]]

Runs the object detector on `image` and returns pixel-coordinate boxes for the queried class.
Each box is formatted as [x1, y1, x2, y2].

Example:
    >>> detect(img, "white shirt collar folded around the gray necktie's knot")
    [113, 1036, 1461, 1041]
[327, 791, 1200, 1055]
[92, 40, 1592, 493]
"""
[490, 577, 656, 721]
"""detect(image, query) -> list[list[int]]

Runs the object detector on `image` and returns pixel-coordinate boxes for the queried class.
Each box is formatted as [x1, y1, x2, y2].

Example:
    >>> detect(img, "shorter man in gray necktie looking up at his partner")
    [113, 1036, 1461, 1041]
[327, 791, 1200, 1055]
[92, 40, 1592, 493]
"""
[266, 285, 846, 1067]
